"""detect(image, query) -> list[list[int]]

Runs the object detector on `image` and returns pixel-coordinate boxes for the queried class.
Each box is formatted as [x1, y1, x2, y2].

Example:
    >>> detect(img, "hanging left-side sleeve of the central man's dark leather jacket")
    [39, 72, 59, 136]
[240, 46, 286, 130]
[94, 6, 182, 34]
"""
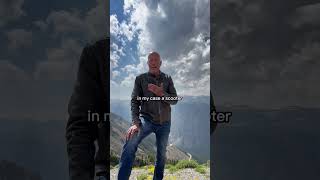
[131, 76, 142, 124]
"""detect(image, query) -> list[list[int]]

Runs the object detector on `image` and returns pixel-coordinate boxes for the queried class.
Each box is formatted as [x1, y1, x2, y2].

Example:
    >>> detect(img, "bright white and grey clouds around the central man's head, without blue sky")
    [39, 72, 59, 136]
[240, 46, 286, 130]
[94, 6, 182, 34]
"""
[111, 0, 210, 98]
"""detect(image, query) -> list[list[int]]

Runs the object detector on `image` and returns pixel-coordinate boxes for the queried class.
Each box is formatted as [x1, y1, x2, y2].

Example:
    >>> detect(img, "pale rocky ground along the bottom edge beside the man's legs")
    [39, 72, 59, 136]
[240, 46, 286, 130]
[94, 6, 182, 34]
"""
[110, 168, 210, 180]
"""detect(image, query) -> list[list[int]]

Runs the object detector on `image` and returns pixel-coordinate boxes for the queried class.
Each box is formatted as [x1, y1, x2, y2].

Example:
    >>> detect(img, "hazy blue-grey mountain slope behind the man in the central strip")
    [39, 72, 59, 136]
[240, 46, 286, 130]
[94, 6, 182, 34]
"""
[111, 96, 210, 163]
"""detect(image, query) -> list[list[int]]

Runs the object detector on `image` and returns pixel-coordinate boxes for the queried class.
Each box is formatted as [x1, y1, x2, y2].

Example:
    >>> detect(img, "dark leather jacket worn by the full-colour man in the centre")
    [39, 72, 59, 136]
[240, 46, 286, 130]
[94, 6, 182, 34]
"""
[131, 72, 178, 124]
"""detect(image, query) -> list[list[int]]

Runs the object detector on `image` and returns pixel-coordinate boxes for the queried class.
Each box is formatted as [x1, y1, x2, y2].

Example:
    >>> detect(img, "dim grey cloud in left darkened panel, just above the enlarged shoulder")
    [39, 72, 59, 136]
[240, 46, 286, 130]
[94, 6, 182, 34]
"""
[33, 1, 109, 42]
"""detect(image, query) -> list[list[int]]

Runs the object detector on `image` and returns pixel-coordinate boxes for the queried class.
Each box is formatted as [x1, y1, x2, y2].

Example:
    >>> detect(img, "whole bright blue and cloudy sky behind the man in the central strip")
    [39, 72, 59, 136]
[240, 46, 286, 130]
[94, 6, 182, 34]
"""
[110, 0, 210, 99]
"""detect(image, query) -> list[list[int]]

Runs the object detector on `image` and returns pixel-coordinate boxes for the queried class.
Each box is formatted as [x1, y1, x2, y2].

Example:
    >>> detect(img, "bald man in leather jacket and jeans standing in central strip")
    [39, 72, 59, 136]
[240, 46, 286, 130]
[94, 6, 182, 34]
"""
[118, 52, 177, 180]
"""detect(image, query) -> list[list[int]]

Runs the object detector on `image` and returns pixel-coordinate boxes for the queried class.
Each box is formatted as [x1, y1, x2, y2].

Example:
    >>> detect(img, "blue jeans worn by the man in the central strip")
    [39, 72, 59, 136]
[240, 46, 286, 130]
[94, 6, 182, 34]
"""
[118, 119, 171, 180]
